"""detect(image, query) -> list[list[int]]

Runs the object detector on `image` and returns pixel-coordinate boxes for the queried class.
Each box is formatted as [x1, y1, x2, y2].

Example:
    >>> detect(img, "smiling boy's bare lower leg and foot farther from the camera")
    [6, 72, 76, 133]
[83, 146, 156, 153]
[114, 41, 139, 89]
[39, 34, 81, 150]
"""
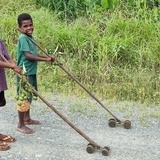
[24, 109, 40, 125]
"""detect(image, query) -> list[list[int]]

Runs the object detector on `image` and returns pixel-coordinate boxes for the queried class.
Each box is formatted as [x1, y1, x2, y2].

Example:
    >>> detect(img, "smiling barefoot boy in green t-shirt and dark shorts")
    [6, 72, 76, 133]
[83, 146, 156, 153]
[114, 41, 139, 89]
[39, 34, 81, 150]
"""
[17, 13, 54, 134]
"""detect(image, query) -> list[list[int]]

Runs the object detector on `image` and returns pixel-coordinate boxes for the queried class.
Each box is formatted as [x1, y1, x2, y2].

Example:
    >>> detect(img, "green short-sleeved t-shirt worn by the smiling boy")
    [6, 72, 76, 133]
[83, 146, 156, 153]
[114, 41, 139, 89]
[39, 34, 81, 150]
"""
[17, 34, 38, 75]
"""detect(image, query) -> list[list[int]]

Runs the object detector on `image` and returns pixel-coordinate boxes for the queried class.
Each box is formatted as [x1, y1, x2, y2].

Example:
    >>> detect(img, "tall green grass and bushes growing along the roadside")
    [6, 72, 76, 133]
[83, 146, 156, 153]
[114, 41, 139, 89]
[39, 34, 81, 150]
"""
[0, 0, 160, 104]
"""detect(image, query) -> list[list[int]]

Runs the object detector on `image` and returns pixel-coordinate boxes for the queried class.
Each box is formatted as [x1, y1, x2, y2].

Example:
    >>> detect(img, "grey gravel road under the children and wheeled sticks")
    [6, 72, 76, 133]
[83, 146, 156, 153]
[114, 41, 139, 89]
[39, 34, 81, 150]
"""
[0, 95, 160, 160]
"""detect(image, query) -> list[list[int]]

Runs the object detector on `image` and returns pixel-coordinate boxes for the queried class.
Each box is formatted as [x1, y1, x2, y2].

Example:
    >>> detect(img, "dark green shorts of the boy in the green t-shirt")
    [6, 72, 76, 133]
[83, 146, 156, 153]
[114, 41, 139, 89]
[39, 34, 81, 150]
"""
[17, 74, 38, 103]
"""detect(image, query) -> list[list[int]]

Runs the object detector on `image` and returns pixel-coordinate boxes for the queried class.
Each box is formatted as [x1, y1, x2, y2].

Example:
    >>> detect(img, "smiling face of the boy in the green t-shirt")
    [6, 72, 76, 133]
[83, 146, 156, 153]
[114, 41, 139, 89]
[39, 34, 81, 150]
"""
[19, 20, 34, 35]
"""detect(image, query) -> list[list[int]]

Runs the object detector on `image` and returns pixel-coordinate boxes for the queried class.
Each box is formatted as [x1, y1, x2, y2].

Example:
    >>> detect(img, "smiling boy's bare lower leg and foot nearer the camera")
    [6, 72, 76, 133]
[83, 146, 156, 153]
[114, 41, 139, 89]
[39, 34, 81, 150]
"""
[17, 111, 35, 134]
